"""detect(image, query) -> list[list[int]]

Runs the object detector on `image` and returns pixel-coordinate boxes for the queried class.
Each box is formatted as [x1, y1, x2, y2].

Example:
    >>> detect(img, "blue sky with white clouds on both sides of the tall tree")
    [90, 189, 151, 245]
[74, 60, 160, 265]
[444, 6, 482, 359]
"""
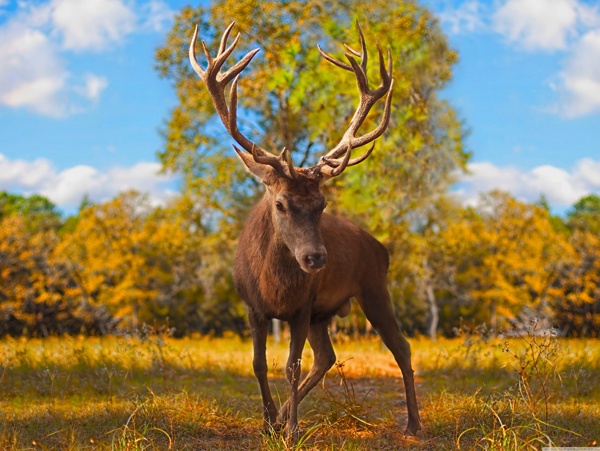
[0, 0, 600, 213]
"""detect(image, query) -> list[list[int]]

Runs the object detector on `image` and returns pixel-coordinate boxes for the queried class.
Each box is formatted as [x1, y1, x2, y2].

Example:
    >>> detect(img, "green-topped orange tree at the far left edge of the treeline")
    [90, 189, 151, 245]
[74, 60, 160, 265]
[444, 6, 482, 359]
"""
[0, 198, 112, 336]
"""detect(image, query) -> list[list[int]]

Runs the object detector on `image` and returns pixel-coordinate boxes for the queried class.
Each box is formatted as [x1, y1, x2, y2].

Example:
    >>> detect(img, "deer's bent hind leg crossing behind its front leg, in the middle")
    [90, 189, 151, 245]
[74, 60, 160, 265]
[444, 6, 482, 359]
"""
[279, 321, 335, 423]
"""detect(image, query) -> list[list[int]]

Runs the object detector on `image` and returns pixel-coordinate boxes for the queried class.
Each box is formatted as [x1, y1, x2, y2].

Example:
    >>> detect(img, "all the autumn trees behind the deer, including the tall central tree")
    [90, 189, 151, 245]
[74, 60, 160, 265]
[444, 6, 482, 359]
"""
[0, 0, 600, 336]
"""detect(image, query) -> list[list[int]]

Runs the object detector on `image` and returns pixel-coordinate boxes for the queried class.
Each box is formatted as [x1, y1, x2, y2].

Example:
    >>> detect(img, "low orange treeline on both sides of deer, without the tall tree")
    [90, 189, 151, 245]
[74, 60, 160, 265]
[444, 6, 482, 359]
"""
[0, 192, 600, 336]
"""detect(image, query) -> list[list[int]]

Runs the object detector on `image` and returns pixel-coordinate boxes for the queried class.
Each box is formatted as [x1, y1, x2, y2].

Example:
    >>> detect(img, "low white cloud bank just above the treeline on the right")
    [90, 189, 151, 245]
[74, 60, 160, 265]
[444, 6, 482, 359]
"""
[456, 158, 600, 209]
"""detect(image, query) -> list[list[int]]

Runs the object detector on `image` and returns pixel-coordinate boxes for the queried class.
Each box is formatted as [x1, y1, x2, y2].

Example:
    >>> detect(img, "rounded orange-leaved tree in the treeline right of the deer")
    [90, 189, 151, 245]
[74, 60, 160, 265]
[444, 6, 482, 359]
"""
[414, 191, 571, 335]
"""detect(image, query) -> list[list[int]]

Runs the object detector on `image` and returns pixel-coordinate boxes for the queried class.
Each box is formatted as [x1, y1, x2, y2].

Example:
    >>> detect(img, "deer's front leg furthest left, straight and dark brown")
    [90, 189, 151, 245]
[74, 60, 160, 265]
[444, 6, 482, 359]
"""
[248, 310, 277, 432]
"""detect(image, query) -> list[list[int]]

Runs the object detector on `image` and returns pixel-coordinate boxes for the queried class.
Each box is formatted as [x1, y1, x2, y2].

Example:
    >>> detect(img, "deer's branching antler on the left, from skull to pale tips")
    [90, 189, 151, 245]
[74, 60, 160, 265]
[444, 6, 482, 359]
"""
[189, 22, 297, 179]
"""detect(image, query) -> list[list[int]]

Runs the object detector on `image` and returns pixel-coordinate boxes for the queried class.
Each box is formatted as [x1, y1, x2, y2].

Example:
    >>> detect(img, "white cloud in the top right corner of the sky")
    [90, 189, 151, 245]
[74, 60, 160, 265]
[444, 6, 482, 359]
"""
[439, 0, 600, 118]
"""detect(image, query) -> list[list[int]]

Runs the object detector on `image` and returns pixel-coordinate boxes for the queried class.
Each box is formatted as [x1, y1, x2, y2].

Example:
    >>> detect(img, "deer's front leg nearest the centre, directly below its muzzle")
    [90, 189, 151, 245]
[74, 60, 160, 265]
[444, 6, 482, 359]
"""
[282, 309, 310, 441]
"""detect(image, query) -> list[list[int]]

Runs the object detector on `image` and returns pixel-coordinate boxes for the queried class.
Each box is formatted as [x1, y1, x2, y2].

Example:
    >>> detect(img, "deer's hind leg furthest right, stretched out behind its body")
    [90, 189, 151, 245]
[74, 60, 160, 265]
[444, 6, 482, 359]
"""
[357, 283, 421, 435]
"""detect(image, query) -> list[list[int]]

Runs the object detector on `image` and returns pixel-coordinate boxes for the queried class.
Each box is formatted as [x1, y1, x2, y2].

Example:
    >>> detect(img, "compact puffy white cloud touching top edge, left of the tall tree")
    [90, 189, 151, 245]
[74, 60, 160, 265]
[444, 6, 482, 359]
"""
[51, 0, 136, 50]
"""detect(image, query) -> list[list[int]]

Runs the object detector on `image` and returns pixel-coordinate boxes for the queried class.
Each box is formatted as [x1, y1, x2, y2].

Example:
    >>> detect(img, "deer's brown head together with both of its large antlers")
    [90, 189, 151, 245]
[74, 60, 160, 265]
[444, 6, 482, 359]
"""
[189, 23, 394, 273]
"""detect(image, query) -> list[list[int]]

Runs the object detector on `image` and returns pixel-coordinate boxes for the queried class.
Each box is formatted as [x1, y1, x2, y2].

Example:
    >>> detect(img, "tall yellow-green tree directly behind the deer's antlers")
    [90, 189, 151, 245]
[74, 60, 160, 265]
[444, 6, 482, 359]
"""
[156, 0, 469, 336]
